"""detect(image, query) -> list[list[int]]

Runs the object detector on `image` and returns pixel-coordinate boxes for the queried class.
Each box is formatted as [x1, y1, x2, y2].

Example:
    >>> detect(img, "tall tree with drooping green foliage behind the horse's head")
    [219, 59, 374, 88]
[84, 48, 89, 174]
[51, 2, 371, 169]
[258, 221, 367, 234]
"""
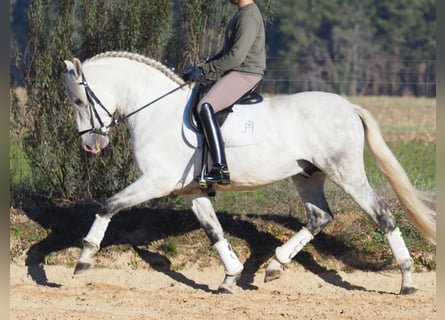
[11, 0, 171, 199]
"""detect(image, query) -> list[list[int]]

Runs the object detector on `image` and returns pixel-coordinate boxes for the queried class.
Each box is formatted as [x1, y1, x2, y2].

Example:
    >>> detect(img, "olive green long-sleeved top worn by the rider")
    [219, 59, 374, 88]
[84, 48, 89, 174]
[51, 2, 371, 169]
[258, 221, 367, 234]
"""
[201, 3, 266, 76]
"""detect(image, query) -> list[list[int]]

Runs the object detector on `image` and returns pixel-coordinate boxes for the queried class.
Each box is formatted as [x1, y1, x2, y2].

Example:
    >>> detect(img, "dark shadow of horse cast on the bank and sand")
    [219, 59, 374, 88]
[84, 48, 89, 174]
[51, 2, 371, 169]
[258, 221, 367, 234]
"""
[24, 204, 375, 292]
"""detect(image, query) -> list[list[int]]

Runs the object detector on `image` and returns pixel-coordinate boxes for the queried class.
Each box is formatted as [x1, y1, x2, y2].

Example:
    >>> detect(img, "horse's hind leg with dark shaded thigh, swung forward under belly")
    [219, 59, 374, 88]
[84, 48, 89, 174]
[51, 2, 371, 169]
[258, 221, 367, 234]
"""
[264, 171, 333, 282]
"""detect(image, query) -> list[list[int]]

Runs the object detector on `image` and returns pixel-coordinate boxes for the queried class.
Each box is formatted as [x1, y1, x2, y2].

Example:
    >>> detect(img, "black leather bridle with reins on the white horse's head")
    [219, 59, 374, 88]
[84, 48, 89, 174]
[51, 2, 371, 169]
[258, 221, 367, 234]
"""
[78, 73, 189, 136]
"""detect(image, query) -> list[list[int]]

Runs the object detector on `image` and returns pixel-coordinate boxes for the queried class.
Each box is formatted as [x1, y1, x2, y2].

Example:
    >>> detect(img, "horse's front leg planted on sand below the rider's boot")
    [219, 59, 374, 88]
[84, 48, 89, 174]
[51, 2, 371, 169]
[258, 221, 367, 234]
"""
[183, 196, 243, 293]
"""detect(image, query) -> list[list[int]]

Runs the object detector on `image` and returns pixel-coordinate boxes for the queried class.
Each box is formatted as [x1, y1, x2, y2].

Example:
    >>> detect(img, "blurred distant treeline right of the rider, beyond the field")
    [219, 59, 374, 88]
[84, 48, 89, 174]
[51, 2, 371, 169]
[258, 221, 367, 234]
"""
[267, 0, 436, 96]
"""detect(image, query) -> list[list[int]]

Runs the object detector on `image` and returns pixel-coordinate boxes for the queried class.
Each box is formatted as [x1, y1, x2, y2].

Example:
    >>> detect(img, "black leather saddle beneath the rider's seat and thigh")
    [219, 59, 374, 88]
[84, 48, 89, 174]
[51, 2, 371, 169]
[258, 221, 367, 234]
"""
[188, 81, 263, 132]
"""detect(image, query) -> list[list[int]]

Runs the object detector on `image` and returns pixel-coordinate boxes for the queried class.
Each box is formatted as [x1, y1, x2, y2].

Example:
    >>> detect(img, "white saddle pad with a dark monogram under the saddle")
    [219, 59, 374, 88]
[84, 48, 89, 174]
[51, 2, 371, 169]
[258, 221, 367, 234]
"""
[182, 98, 265, 148]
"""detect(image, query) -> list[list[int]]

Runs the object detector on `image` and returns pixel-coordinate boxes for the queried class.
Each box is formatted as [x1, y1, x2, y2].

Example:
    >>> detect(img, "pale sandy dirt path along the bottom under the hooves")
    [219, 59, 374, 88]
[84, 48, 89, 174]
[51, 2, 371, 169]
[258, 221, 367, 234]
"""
[10, 264, 437, 320]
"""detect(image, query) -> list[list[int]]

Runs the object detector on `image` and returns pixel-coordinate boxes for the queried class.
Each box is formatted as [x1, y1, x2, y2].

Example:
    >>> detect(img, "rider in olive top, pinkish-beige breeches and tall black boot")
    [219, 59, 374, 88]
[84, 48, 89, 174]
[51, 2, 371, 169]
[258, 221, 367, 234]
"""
[183, 0, 266, 184]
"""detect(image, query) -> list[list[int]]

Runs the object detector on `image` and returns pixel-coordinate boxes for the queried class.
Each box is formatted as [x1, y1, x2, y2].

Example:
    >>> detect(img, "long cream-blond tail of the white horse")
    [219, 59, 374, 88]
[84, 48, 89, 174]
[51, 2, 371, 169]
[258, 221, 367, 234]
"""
[354, 105, 436, 244]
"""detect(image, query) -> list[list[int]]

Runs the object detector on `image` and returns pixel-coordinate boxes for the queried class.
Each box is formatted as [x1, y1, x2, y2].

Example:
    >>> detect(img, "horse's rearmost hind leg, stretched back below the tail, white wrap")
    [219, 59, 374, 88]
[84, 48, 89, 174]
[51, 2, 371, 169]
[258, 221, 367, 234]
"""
[331, 168, 417, 294]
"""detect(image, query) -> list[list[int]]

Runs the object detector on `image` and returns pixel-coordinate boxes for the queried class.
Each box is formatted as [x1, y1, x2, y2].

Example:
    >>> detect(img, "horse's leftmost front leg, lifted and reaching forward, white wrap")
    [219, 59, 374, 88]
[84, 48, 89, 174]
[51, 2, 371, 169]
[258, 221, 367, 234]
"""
[74, 176, 162, 274]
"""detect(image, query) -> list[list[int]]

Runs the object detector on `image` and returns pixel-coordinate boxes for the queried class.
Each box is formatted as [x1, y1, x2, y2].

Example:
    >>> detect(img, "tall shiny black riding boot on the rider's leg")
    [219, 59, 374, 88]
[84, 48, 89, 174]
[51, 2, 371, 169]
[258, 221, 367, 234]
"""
[199, 103, 230, 184]
